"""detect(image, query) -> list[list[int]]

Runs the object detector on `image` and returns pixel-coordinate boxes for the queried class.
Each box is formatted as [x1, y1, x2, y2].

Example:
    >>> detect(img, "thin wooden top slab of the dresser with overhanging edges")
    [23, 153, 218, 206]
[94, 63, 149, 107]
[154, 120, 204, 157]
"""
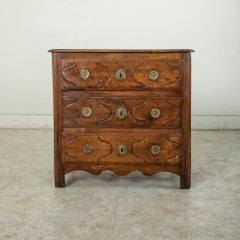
[48, 49, 194, 53]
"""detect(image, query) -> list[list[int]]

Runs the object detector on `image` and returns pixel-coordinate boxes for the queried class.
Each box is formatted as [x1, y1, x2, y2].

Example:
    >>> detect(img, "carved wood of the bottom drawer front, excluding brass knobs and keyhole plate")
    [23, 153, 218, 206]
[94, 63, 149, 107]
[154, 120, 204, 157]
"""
[63, 136, 181, 165]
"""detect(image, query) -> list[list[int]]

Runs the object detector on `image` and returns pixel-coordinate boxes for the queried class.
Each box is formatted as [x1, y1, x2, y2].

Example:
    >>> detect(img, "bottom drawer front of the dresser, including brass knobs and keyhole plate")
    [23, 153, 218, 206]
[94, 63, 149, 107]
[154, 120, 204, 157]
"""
[62, 133, 182, 165]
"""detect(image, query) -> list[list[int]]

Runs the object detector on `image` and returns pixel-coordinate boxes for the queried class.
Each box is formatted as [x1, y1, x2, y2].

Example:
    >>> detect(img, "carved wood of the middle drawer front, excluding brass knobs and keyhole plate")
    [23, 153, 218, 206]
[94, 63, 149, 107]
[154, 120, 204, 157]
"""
[63, 98, 181, 127]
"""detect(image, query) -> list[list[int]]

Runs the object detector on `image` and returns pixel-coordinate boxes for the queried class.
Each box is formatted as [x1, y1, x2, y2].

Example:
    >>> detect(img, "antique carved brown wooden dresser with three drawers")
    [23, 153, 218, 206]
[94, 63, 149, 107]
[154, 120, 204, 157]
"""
[50, 49, 192, 188]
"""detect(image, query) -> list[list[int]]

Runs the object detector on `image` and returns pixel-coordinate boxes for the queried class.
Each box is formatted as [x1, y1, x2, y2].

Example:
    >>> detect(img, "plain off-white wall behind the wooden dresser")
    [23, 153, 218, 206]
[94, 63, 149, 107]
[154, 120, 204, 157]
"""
[0, 0, 240, 128]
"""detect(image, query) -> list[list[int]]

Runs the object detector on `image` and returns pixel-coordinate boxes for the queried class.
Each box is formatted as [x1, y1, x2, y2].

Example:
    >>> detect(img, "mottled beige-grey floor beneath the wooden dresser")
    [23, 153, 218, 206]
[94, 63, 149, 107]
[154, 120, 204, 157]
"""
[0, 130, 240, 240]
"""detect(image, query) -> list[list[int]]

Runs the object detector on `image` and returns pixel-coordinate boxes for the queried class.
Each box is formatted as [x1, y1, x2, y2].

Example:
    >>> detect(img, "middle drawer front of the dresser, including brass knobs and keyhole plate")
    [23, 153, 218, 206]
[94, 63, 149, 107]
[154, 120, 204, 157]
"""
[63, 96, 182, 129]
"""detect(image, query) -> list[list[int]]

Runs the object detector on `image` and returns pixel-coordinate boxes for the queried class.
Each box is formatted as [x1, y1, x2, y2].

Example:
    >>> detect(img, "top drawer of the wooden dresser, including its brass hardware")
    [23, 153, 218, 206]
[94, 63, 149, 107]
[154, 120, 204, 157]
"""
[60, 53, 183, 90]
